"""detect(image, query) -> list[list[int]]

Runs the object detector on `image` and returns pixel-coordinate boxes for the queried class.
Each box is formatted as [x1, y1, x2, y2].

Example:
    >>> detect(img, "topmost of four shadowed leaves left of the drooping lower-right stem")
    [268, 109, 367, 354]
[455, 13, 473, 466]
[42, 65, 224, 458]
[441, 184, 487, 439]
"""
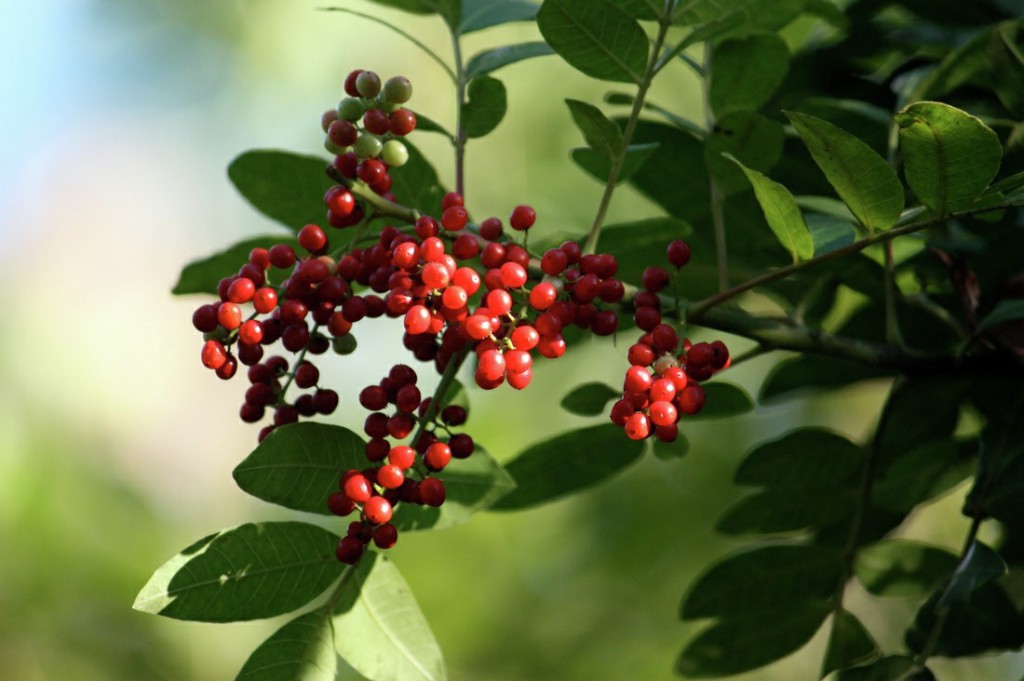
[735, 428, 864, 494]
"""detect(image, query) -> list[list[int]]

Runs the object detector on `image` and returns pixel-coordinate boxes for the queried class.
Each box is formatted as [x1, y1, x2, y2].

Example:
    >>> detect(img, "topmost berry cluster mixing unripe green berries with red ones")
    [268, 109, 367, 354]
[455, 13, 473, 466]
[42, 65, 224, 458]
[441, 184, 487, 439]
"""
[321, 69, 416, 227]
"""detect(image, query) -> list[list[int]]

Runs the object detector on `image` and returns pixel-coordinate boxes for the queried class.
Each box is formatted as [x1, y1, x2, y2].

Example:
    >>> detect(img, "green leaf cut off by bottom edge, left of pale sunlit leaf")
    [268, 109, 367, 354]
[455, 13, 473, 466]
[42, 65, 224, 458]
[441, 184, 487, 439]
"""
[234, 610, 338, 681]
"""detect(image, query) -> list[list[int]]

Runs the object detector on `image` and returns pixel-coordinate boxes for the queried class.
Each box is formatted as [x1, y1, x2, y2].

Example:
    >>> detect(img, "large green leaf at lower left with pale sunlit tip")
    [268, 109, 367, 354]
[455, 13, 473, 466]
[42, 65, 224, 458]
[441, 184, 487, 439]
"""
[133, 522, 343, 622]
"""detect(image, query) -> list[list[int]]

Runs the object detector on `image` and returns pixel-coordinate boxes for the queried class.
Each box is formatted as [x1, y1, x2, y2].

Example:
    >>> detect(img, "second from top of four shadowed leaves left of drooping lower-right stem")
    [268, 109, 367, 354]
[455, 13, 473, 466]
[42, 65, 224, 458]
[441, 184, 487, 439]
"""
[715, 487, 858, 535]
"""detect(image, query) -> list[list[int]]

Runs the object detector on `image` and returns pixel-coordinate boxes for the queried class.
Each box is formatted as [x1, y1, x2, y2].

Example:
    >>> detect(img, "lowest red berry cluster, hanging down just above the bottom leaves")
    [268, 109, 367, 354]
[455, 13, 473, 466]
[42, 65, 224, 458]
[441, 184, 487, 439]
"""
[328, 365, 475, 564]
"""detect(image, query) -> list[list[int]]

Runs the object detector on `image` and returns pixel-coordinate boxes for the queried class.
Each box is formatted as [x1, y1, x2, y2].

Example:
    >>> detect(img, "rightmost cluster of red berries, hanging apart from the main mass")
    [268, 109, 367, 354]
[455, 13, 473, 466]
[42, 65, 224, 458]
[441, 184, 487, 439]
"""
[610, 241, 730, 442]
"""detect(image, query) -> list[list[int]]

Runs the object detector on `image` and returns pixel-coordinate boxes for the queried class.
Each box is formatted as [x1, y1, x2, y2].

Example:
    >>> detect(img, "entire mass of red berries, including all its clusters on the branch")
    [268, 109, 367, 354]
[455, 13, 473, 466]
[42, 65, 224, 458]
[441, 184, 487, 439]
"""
[193, 71, 728, 563]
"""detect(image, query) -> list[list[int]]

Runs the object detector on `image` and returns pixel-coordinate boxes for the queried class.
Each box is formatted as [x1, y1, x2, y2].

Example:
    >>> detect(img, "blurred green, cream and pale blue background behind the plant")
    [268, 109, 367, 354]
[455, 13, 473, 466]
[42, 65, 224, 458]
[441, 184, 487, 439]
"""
[6, 0, 1024, 681]
